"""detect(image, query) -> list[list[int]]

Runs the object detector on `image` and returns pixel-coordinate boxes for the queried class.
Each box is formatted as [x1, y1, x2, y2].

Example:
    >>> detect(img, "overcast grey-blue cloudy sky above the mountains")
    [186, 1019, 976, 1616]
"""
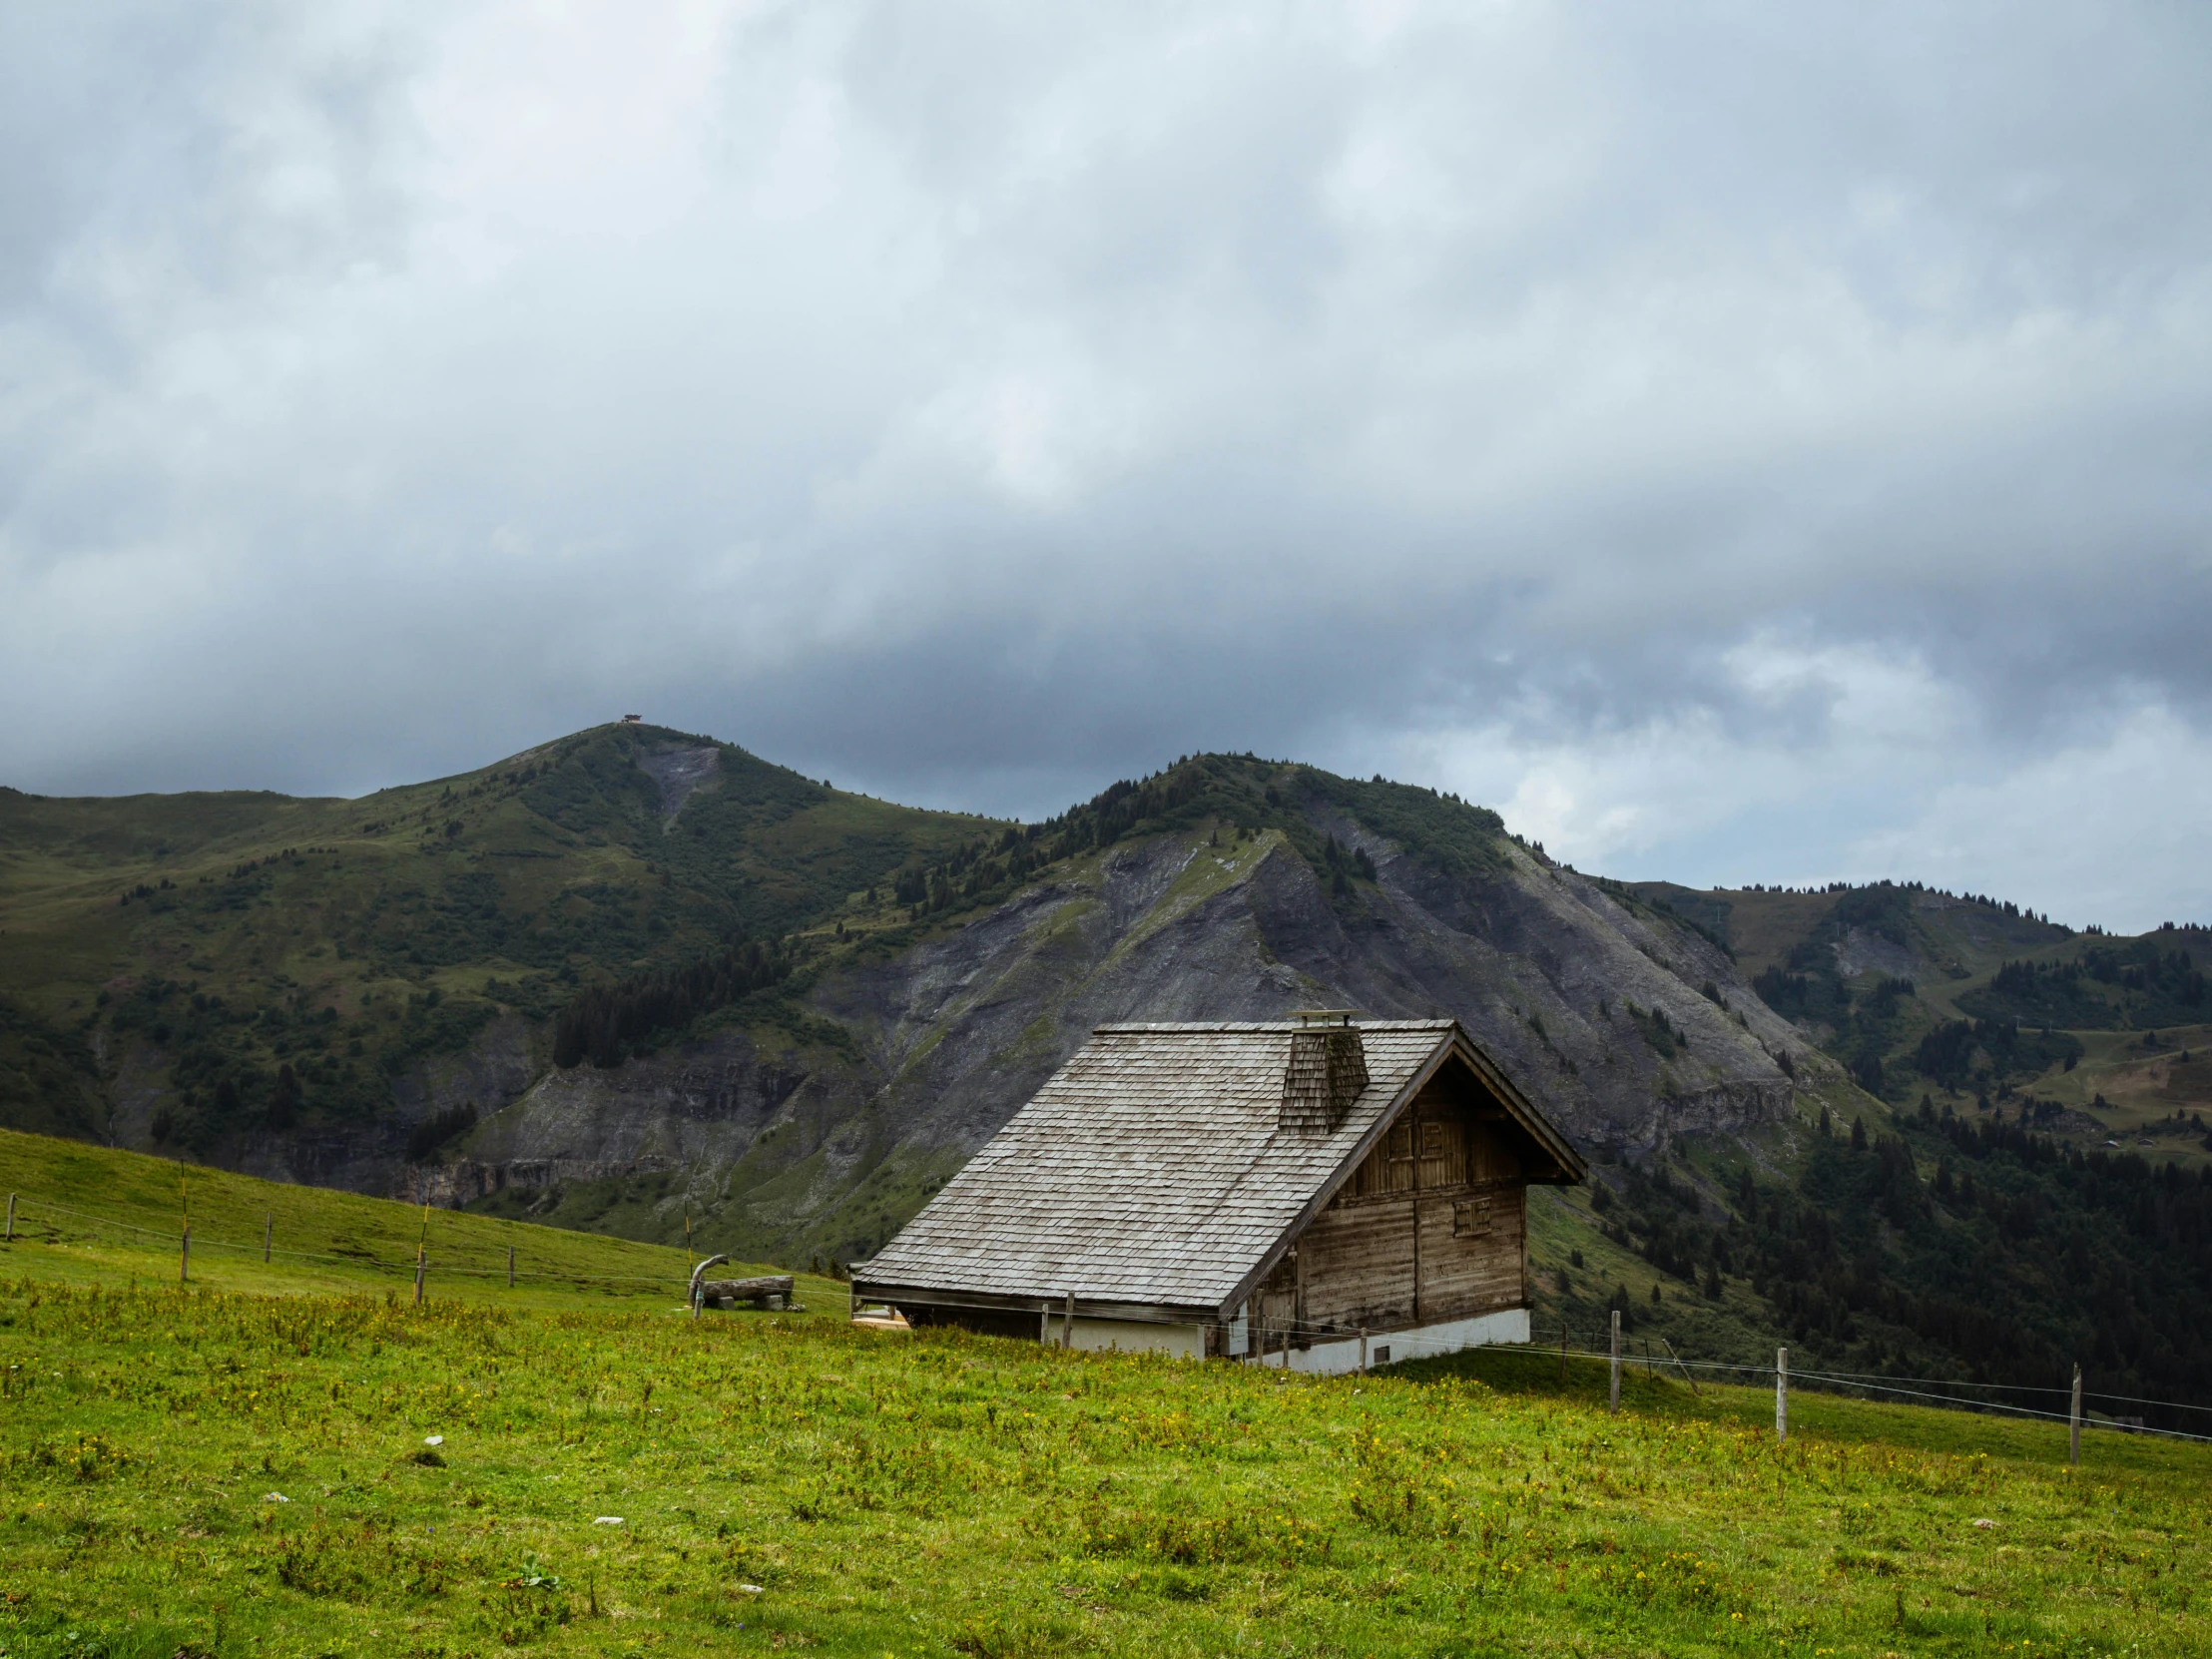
[0, 0, 2212, 929]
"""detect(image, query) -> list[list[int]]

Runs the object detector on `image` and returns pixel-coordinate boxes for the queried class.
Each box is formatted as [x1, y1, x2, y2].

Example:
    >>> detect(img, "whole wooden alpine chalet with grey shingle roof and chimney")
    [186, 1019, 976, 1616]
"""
[853, 1011, 1588, 1372]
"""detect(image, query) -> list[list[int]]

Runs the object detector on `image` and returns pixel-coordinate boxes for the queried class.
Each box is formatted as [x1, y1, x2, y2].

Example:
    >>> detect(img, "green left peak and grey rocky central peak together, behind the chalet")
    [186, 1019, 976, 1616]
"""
[0, 726, 1847, 1257]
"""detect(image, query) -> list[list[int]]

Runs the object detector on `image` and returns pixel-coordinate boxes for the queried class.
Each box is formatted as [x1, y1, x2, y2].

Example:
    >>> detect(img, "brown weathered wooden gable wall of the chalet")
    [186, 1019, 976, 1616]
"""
[1252, 1066, 1528, 1348]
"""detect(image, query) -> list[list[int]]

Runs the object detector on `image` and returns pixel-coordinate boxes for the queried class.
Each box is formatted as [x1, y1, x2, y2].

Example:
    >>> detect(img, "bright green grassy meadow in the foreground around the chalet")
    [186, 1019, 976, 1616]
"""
[0, 1137, 2212, 1659]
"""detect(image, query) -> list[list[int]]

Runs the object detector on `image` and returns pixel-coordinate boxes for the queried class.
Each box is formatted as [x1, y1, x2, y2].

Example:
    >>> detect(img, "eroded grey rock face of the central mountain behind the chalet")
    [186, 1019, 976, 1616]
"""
[439, 808, 1827, 1259]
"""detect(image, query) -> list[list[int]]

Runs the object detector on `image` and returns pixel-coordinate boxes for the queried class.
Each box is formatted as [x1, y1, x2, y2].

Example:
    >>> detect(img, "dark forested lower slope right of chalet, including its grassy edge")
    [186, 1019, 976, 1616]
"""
[1530, 1106, 2212, 1431]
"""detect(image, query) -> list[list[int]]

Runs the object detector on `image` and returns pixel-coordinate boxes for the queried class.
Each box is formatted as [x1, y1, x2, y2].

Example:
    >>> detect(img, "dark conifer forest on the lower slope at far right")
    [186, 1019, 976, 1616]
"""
[1593, 1104, 2212, 1426]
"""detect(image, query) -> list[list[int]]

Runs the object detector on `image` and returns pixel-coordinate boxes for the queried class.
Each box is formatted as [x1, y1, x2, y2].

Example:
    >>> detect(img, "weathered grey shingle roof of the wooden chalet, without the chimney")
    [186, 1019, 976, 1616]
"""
[853, 1020, 1581, 1319]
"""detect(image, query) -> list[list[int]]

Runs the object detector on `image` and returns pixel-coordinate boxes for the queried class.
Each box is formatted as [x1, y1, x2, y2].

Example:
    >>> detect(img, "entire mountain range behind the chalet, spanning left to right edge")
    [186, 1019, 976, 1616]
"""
[0, 726, 2212, 1415]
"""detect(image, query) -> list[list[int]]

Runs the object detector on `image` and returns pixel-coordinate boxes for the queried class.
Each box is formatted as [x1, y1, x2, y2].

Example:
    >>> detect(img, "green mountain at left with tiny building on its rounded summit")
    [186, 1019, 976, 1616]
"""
[0, 726, 986, 1159]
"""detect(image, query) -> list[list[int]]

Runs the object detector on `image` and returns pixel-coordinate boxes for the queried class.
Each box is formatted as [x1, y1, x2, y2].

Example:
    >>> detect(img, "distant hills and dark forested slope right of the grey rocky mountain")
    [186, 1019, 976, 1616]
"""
[1535, 882, 2212, 1424]
